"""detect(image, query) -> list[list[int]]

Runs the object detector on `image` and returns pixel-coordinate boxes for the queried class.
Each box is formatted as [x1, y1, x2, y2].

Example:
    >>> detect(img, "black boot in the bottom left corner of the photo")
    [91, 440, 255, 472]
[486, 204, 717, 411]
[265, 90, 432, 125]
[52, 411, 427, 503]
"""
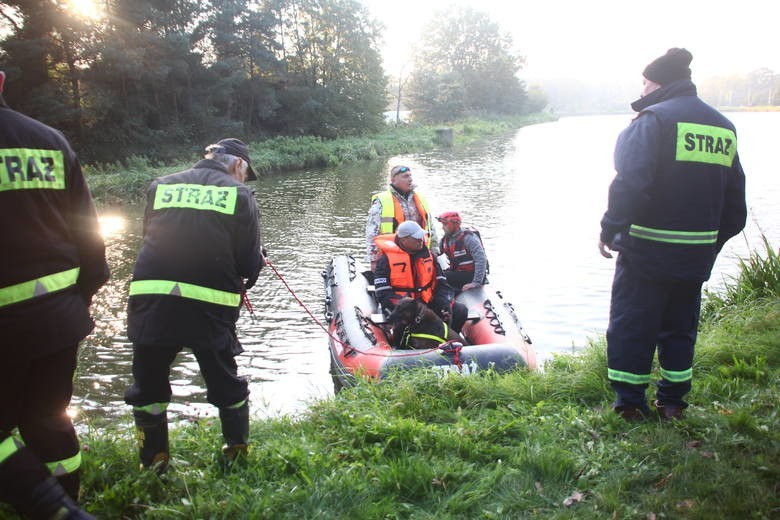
[0, 448, 94, 520]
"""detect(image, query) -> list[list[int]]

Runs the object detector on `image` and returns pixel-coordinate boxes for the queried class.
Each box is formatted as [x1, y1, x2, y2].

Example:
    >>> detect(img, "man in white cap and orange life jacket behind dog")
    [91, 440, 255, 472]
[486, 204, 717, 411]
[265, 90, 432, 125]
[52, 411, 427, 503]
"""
[374, 220, 468, 344]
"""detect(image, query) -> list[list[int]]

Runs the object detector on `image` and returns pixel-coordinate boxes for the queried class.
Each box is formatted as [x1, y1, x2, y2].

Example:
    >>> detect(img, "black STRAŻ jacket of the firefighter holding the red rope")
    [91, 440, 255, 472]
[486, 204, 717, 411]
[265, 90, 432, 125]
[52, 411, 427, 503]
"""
[127, 159, 262, 353]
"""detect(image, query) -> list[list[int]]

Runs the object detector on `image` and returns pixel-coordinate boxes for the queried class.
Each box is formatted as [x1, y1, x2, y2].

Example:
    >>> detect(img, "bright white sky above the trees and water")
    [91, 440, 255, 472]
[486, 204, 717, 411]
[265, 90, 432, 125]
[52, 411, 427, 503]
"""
[361, 0, 780, 82]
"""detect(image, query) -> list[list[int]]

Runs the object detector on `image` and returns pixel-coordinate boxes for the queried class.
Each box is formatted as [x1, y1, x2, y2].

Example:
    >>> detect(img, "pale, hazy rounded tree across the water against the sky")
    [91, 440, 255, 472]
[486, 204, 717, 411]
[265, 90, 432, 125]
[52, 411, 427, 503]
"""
[409, 8, 531, 121]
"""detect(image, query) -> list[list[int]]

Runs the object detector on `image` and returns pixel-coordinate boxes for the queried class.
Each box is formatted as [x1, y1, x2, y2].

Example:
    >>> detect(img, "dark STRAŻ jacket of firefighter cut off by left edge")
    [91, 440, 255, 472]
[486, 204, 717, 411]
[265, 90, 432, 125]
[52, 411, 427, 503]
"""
[0, 97, 109, 359]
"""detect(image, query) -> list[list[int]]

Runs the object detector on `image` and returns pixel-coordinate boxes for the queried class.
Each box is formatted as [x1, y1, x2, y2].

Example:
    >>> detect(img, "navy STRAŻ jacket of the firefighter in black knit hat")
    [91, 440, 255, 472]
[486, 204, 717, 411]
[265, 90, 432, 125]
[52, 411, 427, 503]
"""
[601, 80, 747, 282]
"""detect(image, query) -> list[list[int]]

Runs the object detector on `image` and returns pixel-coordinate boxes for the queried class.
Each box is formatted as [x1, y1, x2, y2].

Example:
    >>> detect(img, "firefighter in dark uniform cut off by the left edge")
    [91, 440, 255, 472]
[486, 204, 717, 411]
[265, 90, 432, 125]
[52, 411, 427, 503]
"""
[0, 72, 109, 518]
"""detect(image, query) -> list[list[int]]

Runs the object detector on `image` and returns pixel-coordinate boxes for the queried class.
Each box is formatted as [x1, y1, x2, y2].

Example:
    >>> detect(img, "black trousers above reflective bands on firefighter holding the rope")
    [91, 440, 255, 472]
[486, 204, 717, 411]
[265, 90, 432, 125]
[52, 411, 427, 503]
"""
[125, 344, 249, 408]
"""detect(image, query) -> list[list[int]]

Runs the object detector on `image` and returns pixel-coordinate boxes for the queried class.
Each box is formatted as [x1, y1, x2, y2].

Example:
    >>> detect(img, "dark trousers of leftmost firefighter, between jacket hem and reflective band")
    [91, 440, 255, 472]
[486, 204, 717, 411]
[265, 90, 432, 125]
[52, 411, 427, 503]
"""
[0, 344, 80, 472]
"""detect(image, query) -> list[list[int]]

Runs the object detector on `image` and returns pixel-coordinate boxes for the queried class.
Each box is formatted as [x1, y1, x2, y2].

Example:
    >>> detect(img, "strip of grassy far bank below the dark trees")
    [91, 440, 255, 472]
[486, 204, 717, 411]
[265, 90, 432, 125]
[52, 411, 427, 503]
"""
[84, 113, 554, 204]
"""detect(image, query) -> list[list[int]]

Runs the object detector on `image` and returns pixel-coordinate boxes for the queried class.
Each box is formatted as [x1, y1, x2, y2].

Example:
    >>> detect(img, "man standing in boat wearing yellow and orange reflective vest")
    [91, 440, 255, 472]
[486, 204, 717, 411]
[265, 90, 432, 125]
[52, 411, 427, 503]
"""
[365, 166, 439, 271]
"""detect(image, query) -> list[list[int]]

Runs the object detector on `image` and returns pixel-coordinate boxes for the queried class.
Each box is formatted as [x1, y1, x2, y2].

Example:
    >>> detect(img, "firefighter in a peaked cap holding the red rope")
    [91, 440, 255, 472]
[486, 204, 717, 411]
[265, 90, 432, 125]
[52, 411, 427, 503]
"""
[125, 138, 264, 471]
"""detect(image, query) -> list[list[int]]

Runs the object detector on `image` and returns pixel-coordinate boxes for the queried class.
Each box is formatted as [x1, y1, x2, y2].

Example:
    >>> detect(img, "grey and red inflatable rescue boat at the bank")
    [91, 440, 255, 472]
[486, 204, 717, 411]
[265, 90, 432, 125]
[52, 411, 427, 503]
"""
[322, 256, 536, 392]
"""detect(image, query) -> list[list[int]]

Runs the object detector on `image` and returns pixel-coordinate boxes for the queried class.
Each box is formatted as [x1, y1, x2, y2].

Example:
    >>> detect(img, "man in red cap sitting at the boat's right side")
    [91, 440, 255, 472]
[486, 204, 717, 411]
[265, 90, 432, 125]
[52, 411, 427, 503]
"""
[436, 211, 488, 291]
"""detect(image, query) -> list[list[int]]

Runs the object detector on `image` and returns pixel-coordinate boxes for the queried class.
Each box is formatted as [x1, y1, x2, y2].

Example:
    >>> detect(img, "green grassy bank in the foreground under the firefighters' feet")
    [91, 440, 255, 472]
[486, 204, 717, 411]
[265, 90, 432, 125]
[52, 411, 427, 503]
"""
[0, 243, 780, 519]
